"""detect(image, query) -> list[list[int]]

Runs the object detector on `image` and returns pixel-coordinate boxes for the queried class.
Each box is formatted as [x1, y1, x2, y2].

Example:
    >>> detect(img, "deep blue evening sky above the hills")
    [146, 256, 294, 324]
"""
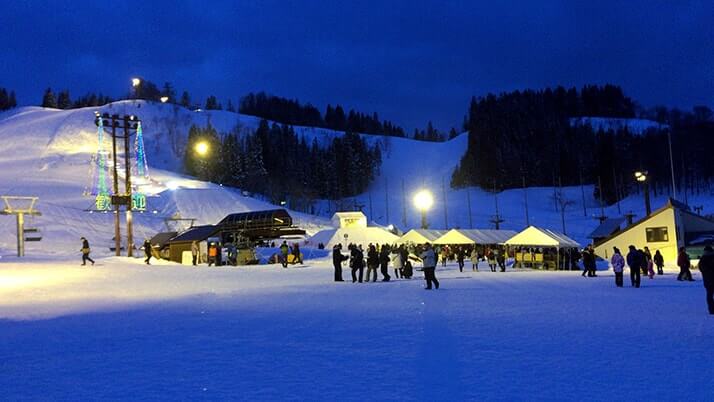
[0, 0, 714, 130]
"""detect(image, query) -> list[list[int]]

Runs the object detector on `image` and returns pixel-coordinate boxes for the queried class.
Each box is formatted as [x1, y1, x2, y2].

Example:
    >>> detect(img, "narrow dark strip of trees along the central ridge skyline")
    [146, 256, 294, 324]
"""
[238, 92, 404, 137]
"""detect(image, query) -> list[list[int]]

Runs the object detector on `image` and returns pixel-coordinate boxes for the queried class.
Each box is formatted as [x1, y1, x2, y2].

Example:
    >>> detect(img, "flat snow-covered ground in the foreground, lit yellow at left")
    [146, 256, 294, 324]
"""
[0, 257, 714, 401]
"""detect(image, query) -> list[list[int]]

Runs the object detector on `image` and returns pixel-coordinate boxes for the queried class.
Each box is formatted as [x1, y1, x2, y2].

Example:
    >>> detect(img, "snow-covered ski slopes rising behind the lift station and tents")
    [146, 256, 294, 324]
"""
[0, 101, 711, 255]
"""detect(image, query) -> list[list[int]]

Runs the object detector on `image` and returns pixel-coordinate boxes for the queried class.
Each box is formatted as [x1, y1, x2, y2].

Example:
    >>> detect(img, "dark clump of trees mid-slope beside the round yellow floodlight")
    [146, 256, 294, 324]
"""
[184, 119, 381, 204]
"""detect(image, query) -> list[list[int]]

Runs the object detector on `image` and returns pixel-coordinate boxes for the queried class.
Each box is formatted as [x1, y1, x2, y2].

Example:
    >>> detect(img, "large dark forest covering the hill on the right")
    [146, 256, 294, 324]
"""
[451, 85, 714, 204]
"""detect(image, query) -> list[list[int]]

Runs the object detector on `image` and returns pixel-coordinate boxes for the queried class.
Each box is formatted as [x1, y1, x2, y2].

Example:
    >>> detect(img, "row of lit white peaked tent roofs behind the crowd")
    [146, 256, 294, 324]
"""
[310, 226, 580, 248]
